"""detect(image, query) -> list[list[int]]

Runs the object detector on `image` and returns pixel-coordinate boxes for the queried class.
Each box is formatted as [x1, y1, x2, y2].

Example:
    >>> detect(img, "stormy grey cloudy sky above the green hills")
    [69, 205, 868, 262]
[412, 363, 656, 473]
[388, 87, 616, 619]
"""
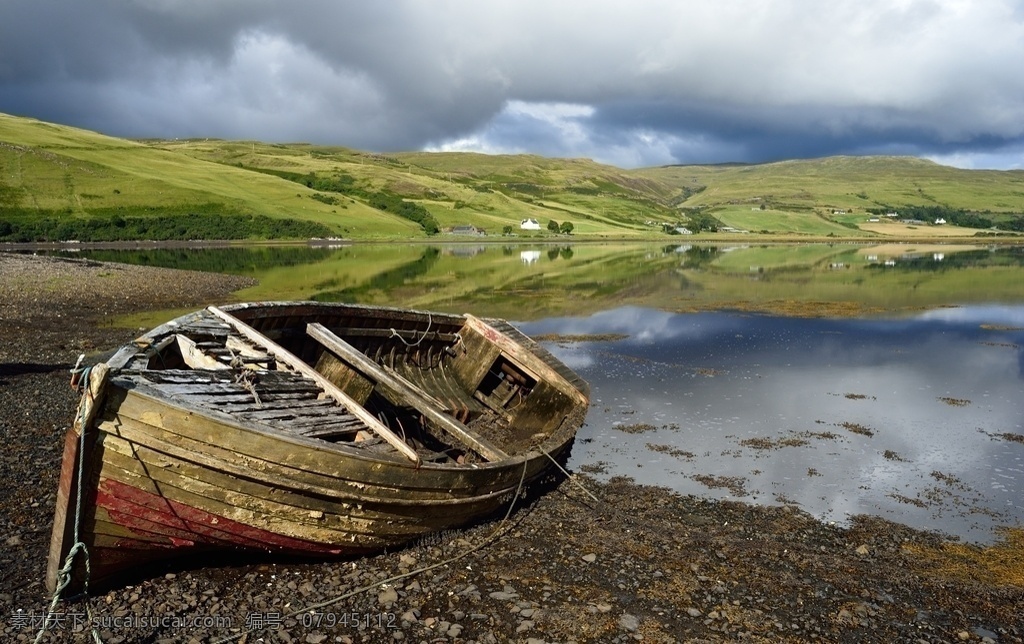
[0, 0, 1024, 169]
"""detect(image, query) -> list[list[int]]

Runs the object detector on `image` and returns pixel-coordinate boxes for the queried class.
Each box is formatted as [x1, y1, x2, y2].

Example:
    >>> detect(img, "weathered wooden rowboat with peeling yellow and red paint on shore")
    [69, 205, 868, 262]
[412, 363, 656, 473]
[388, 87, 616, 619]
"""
[47, 302, 589, 591]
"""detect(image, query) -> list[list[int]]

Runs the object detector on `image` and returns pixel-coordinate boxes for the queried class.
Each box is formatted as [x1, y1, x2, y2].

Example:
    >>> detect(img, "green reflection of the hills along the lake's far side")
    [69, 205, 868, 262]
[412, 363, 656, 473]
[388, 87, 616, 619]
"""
[32, 242, 1024, 319]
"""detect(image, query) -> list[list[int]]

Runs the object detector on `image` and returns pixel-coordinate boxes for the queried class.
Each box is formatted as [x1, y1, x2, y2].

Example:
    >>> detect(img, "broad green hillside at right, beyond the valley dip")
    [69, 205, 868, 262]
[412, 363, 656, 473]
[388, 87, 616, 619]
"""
[638, 157, 1024, 237]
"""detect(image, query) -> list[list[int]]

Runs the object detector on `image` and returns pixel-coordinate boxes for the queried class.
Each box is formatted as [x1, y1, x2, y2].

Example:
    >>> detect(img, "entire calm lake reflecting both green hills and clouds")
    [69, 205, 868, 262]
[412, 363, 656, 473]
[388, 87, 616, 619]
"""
[41, 244, 1024, 542]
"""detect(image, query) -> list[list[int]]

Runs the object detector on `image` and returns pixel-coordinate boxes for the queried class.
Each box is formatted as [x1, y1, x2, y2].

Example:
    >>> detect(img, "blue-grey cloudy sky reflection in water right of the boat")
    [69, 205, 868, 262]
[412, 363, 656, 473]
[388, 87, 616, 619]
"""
[523, 306, 1024, 541]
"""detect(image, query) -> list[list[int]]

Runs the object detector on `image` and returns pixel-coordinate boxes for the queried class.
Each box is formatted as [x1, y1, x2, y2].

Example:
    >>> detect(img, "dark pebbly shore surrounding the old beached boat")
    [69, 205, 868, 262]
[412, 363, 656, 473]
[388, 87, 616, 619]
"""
[0, 253, 1024, 644]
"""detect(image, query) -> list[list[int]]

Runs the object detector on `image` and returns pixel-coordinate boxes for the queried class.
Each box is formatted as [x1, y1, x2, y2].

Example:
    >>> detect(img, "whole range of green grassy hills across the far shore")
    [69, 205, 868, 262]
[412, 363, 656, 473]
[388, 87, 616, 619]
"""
[0, 115, 1024, 242]
